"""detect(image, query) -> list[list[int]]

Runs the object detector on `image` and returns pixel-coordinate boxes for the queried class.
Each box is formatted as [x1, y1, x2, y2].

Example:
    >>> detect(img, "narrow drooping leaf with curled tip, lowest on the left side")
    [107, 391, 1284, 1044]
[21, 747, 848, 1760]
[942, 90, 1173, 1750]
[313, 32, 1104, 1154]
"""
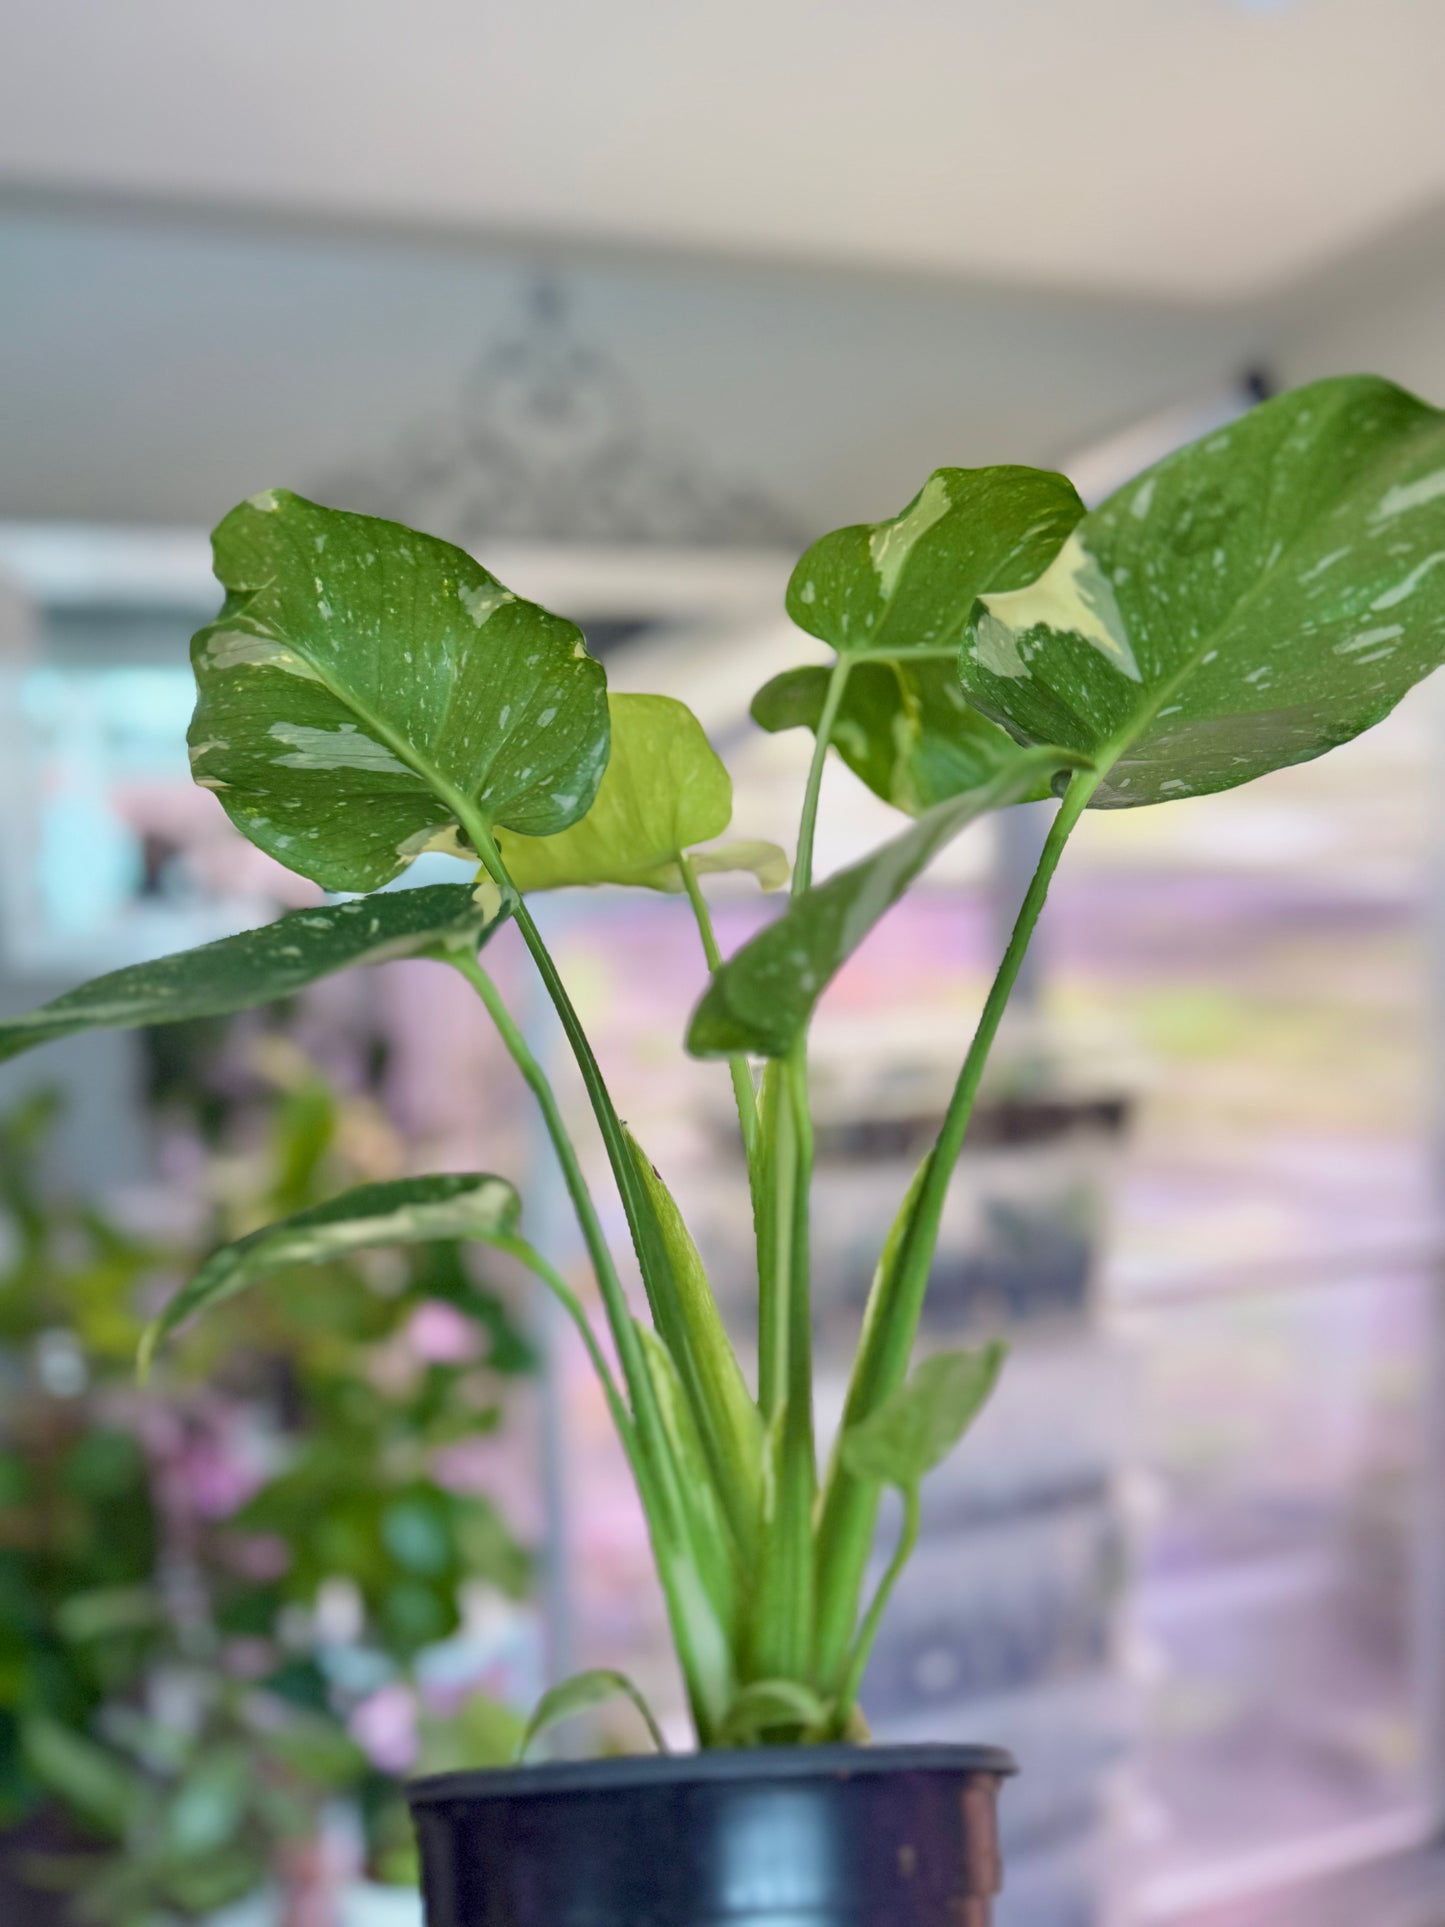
[141, 1172, 522, 1372]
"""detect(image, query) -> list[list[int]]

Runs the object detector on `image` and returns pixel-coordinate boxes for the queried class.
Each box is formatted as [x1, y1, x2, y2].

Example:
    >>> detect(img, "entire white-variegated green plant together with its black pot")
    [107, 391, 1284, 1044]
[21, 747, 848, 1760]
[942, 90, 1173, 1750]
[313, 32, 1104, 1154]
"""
[0, 378, 1445, 1927]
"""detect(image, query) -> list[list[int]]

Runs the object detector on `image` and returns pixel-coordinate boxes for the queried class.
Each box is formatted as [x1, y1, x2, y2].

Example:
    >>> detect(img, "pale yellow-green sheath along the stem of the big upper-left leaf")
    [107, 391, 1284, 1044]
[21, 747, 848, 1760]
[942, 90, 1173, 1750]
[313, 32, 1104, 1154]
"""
[626, 1131, 763, 1555]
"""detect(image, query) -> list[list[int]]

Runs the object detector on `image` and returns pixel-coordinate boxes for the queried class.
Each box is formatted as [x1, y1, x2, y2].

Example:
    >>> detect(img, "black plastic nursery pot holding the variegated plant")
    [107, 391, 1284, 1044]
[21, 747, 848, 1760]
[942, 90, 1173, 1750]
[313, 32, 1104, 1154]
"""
[408, 1746, 1013, 1927]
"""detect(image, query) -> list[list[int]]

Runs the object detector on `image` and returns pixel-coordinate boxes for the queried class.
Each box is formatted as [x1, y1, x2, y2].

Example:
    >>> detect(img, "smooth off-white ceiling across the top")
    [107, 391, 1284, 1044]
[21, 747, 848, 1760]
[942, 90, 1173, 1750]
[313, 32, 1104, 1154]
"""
[0, 0, 1445, 301]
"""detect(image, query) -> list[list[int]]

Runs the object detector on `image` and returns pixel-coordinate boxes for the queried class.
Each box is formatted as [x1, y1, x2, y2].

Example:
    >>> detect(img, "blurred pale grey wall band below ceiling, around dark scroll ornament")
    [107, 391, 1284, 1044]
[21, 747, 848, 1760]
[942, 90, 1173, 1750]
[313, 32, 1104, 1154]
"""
[0, 208, 1258, 534]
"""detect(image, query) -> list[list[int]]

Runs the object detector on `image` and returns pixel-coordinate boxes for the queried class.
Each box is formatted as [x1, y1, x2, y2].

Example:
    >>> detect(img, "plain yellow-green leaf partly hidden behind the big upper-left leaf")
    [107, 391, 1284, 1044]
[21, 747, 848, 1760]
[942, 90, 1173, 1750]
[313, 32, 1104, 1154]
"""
[497, 696, 786, 892]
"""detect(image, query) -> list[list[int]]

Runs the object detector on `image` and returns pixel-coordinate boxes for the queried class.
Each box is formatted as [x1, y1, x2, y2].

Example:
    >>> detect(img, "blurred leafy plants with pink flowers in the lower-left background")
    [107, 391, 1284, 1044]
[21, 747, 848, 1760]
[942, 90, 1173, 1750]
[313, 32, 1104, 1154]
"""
[0, 1027, 532, 1927]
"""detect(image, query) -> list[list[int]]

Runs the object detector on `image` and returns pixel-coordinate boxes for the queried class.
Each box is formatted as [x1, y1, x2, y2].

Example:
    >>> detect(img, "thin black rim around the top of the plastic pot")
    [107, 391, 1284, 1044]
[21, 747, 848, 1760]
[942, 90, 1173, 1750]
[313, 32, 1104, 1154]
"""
[407, 1744, 1019, 1808]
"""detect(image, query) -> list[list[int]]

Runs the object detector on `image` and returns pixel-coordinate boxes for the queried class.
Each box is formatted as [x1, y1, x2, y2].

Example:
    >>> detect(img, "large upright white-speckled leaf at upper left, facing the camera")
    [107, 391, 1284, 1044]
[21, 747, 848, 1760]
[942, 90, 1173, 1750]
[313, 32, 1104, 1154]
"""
[189, 489, 607, 890]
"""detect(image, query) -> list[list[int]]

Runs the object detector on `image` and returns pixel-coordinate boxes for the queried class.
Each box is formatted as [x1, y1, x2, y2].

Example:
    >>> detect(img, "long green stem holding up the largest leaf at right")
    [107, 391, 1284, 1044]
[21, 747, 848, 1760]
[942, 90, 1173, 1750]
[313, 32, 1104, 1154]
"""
[819, 769, 1100, 1680]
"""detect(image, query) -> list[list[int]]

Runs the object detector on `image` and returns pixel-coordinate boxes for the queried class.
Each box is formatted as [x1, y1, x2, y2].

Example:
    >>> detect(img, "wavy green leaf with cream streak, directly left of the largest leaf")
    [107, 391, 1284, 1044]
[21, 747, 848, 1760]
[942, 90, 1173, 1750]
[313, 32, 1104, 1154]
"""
[788, 468, 1083, 655]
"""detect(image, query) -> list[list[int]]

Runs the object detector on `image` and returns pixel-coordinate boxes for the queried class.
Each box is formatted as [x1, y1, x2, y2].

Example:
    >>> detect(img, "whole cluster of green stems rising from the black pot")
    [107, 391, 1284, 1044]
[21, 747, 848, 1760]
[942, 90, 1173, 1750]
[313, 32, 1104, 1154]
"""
[441, 657, 1096, 1746]
